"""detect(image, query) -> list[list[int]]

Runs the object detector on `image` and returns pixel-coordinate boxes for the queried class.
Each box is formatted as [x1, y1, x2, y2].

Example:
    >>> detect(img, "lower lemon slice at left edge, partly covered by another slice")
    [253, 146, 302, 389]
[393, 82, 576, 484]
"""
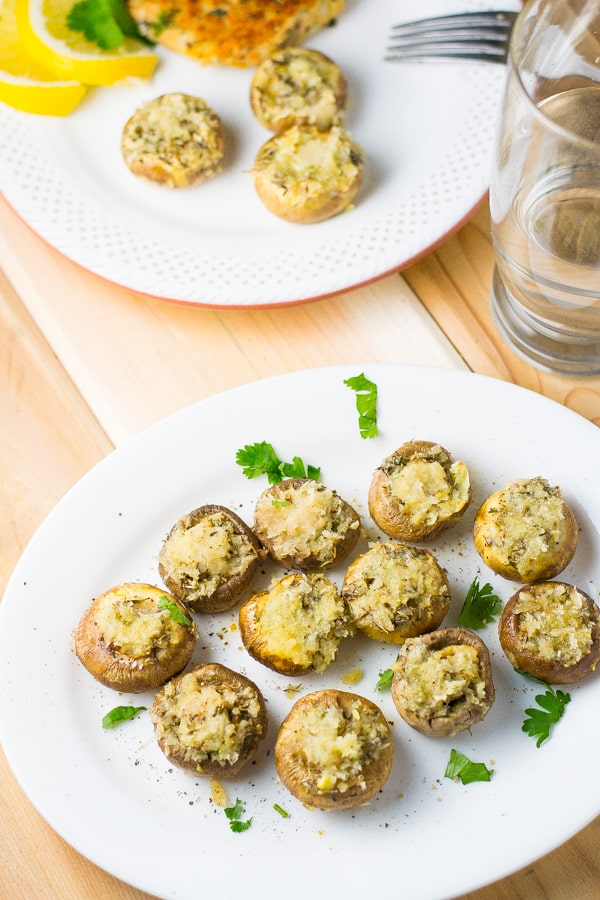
[0, 0, 86, 116]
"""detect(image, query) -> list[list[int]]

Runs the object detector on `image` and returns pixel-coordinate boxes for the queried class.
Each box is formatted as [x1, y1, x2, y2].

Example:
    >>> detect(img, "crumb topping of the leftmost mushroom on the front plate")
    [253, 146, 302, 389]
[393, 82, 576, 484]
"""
[94, 586, 193, 659]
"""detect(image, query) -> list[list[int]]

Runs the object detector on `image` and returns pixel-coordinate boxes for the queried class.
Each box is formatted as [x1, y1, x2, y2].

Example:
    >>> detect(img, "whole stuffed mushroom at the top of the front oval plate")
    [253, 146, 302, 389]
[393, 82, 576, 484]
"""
[368, 441, 471, 543]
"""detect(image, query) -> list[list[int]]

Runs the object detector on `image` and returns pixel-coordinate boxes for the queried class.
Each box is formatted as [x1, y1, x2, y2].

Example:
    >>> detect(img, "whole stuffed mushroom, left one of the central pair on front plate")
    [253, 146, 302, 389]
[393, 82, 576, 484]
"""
[239, 572, 353, 676]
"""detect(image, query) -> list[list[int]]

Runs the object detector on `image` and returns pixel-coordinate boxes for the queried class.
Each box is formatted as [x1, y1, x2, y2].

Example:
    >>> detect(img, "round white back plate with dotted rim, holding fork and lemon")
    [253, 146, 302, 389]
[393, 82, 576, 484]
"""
[0, 0, 518, 307]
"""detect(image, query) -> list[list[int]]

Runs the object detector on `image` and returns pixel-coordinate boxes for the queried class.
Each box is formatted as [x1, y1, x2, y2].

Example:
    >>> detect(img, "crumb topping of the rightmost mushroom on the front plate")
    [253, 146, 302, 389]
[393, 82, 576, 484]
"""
[514, 583, 593, 666]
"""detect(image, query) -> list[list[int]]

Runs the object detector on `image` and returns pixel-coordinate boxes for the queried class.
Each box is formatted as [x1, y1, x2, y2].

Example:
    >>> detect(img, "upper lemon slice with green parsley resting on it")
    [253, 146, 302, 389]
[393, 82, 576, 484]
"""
[16, 0, 158, 85]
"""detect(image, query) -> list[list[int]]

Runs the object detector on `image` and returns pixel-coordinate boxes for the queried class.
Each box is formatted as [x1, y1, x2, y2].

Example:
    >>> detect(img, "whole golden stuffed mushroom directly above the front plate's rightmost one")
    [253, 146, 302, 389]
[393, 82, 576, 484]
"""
[473, 477, 578, 584]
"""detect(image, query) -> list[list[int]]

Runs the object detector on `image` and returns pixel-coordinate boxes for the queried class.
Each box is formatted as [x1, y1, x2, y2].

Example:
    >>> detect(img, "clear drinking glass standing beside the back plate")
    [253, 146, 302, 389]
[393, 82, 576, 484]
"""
[490, 0, 600, 375]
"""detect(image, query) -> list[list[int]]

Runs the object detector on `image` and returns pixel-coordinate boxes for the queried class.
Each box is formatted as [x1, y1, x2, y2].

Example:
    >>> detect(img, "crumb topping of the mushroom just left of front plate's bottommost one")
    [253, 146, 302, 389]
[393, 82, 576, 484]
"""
[155, 672, 260, 764]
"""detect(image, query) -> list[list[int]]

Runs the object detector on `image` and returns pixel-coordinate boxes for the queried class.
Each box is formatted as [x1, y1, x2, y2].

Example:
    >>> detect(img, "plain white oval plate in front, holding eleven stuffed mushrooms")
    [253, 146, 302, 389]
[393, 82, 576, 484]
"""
[0, 365, 600, 900]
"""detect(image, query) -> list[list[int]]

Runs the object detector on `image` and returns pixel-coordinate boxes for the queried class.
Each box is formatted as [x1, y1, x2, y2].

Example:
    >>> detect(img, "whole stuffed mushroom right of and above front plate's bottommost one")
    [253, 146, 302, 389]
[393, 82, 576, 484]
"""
[392, 628, 495, 737]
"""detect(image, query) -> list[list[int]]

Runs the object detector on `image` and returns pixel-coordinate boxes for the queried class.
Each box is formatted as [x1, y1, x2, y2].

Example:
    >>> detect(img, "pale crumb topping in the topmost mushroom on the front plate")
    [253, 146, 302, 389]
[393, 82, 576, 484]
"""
[389, 459, 469, 525]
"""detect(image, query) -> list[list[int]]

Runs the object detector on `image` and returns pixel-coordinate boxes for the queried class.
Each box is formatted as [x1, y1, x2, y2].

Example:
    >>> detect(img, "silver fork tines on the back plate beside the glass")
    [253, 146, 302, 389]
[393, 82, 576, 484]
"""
[384, 10, 518, 63]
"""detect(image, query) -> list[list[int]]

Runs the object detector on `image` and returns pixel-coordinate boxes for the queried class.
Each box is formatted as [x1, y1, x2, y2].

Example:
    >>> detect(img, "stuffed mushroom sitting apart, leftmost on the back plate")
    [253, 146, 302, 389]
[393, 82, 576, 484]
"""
[121, 93, 225, 188]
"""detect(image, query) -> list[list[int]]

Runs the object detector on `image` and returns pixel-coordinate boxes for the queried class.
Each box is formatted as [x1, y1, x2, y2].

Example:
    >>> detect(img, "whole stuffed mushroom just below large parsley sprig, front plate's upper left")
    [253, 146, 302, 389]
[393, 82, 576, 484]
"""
[254, 478, 360, 572]
